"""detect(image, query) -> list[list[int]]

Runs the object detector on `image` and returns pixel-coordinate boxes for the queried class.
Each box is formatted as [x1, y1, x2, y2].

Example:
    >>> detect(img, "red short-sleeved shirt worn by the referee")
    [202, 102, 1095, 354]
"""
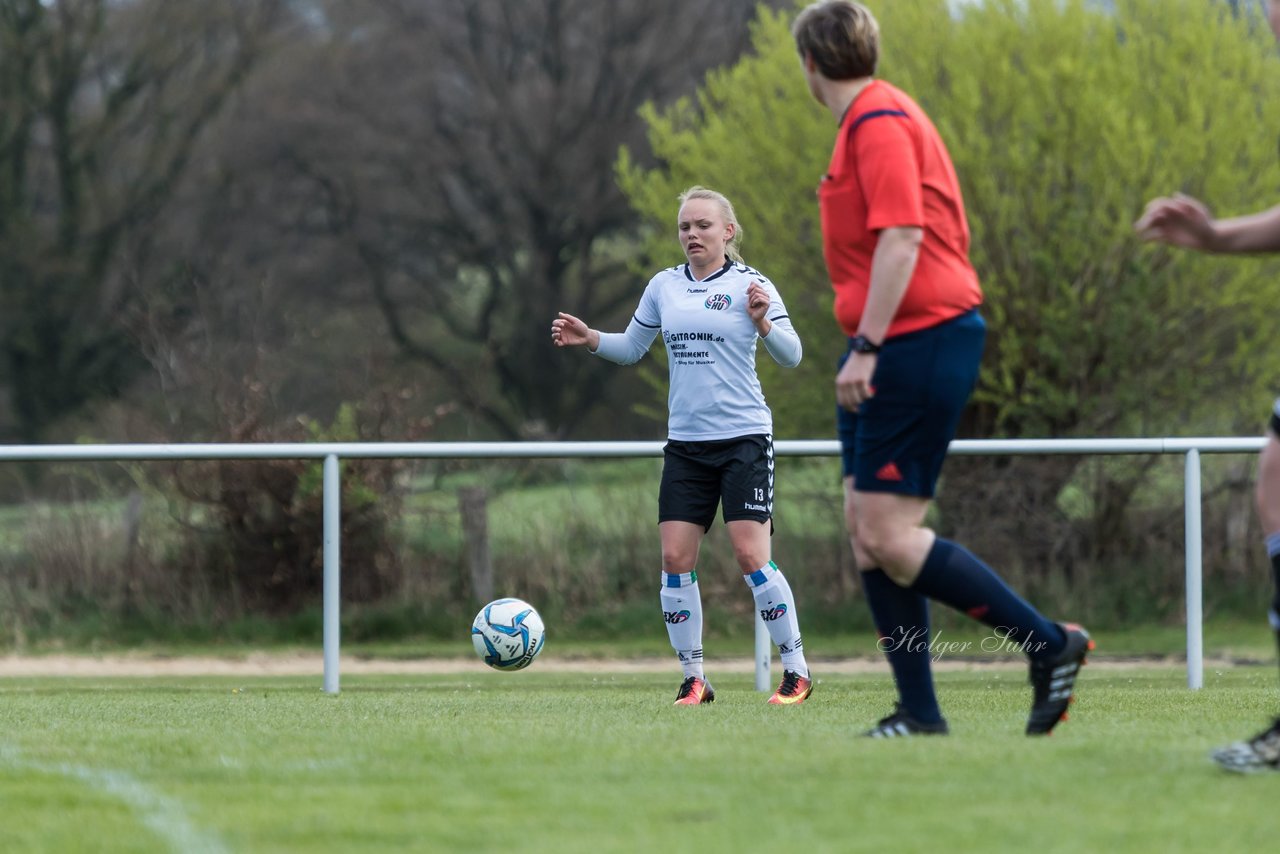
[818, 81, 982, 337]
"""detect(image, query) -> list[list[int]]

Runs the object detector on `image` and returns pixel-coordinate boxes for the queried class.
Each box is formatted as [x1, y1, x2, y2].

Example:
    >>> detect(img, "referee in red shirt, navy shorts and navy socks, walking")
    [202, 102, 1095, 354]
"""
[792, 0, 1092, 737]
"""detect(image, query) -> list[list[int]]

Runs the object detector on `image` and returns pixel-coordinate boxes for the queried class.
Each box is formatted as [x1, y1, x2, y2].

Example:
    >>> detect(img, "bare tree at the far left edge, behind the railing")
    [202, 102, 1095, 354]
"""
[0, 0, 282, 442]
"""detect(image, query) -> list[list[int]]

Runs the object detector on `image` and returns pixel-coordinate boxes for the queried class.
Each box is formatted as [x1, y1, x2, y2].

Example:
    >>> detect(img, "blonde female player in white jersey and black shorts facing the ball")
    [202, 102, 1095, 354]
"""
[552, 187, 813, 705]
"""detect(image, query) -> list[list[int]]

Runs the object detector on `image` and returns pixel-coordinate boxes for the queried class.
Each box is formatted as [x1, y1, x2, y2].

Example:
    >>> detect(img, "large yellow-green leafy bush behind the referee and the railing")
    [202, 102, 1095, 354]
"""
[618, 0, 1280, 577]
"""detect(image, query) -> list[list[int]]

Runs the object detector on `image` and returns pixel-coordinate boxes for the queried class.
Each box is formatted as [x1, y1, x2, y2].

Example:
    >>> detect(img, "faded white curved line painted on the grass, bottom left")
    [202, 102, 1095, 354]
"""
[0, 744, 228, 854]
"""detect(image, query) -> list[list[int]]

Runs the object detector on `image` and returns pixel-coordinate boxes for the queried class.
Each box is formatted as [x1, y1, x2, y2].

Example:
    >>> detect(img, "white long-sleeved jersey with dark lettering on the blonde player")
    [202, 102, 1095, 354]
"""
[595, 261, 801, 442]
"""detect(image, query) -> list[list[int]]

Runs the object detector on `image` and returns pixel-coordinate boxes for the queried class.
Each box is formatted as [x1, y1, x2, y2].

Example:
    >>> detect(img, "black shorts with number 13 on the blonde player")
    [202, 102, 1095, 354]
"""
[658, 435, 773, 530]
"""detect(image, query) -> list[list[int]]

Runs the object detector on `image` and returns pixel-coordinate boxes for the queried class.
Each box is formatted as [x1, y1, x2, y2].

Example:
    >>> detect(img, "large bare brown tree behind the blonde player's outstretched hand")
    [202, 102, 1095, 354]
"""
[256, 0, 783, 438]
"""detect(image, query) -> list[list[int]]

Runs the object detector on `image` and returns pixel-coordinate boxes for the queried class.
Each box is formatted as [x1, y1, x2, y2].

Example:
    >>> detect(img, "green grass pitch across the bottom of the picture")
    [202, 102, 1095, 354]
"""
[0, 661, 1280, 851]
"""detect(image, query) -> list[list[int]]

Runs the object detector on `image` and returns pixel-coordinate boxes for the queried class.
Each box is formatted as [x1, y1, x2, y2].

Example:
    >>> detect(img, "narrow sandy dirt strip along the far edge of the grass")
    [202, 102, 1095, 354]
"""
[0, 652, 1223, 677]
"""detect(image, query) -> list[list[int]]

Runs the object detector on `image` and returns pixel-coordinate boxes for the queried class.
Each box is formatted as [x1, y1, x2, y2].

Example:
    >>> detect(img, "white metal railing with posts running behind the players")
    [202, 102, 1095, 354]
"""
[0, 437, 1266, 694]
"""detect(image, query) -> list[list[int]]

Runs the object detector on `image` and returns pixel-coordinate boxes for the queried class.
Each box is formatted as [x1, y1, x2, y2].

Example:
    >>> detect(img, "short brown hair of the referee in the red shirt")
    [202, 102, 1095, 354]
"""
[791, 0, 879, 81]
